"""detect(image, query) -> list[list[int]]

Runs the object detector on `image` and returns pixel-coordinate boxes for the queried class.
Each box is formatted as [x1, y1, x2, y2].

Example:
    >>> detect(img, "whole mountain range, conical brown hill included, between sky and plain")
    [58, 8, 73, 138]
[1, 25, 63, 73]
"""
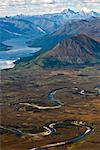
[0, 9, 100, 68]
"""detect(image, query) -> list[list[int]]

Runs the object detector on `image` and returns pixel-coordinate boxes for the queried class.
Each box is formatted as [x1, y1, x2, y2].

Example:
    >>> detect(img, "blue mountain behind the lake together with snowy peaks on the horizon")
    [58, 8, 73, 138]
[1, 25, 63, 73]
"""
[0, 9, 100, 41]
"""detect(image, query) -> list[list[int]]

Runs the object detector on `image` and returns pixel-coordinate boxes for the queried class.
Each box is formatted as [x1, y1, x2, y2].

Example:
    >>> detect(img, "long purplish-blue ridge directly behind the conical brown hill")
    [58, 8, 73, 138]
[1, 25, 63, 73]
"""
[28, 17, 100, 49]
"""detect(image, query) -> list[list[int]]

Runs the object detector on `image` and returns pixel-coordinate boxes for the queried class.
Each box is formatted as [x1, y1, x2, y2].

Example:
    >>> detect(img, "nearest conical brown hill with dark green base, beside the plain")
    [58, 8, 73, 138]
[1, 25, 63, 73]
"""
[35, 34, 100, 68]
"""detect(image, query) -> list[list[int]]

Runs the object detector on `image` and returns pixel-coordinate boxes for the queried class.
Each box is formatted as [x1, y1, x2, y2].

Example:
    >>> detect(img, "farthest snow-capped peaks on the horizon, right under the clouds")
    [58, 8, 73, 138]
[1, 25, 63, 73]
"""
[24, 9, 100, 27]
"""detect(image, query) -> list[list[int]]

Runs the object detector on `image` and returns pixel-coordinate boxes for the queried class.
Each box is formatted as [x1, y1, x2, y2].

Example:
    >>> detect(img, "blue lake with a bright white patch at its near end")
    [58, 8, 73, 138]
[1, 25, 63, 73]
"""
[0, 38, 41, 70]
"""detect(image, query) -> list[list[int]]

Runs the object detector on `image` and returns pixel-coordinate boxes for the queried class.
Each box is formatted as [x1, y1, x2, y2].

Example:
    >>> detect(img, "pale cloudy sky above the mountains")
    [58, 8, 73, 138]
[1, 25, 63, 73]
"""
[0, 0, 100, 16]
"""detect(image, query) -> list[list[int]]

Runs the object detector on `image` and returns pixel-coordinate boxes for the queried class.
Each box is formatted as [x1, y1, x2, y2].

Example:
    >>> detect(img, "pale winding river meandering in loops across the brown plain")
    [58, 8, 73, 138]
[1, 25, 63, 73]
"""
[0, 87, 93, 150]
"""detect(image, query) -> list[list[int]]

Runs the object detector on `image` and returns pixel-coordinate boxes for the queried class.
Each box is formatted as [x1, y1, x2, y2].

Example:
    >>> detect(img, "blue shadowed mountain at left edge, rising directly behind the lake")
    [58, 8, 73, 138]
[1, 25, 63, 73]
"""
[0, 18, 46, 41]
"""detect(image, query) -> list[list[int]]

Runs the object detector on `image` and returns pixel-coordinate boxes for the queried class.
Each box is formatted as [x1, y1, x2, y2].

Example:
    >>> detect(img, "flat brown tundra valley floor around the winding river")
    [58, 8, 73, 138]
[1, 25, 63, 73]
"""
[0, 65, 100, 150]
